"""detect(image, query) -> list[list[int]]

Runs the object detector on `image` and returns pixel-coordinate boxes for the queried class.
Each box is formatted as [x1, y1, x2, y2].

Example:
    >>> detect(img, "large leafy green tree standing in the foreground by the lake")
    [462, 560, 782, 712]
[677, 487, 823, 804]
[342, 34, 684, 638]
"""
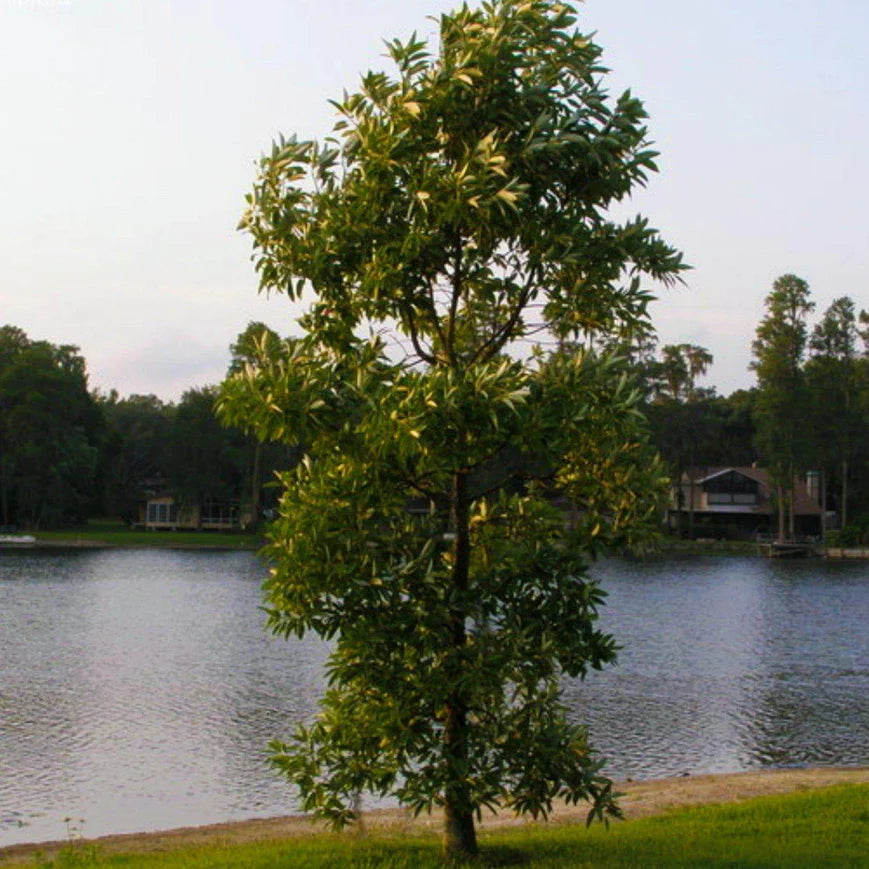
[219, 0, 682, 854]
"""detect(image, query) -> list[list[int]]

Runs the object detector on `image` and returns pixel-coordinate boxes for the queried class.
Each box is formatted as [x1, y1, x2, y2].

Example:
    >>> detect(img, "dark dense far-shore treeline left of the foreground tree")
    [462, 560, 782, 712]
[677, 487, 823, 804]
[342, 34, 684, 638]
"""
[0, 324, 292, 530]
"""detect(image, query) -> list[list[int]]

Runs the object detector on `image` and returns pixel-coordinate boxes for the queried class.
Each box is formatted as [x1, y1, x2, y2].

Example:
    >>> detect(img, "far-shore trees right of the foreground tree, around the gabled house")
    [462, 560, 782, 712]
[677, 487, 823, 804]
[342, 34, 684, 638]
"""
[624, 274, 869, 543]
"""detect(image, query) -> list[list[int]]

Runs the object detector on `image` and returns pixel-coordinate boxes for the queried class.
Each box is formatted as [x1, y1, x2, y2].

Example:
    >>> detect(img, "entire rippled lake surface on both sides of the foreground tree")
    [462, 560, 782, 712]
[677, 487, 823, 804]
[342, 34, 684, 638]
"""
[0, 551, 869, 845]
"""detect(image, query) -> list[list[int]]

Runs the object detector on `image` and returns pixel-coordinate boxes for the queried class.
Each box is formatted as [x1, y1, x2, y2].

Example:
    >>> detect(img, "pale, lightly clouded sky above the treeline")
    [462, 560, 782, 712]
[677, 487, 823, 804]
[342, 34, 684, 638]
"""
[0, 0, 869, 400]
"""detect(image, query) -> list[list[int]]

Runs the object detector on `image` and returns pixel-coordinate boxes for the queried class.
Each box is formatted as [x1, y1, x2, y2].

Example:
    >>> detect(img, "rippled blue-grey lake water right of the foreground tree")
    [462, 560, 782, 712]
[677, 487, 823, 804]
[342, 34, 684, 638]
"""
[567, 558, 869, 778]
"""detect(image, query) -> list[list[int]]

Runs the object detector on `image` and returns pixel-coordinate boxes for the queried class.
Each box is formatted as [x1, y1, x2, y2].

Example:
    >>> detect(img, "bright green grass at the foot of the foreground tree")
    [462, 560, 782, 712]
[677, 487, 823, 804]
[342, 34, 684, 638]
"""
[20, 785, 869, 869]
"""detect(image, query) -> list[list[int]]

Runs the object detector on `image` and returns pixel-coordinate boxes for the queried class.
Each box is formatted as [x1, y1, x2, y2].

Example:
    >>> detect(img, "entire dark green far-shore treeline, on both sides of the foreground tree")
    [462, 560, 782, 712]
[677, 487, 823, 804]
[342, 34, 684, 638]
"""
[0, 275, 869, 542]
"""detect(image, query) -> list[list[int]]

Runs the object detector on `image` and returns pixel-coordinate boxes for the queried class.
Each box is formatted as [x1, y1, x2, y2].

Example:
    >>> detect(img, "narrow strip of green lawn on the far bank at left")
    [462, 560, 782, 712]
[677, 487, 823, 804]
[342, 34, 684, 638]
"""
[34, 519, 262, 549]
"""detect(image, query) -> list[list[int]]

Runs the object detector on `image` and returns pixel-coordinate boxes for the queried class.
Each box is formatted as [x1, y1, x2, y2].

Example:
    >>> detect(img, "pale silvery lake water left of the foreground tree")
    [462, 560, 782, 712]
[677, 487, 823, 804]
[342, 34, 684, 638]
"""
[0, 551, 325, 844]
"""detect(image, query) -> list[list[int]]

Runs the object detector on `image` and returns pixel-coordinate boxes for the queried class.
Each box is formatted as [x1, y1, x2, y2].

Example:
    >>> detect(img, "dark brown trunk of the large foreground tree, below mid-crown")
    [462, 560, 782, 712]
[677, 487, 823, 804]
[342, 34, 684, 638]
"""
[443, 470, 477, 858]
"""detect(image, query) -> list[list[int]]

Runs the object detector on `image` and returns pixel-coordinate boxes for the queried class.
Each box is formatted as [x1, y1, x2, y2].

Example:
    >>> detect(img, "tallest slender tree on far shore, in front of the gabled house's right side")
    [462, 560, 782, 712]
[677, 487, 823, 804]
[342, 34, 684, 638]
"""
[751, 274, 815, 540]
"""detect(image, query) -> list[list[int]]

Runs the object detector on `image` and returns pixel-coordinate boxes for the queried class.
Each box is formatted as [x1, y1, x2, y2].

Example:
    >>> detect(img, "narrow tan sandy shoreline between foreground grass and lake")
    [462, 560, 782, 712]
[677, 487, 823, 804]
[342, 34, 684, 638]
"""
[0, 767, 869, 865]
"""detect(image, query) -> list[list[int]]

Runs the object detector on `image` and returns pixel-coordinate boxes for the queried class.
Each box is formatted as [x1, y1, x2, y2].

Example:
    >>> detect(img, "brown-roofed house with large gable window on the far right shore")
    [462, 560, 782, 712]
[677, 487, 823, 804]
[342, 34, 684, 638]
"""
[667, 466, 821, 537]
